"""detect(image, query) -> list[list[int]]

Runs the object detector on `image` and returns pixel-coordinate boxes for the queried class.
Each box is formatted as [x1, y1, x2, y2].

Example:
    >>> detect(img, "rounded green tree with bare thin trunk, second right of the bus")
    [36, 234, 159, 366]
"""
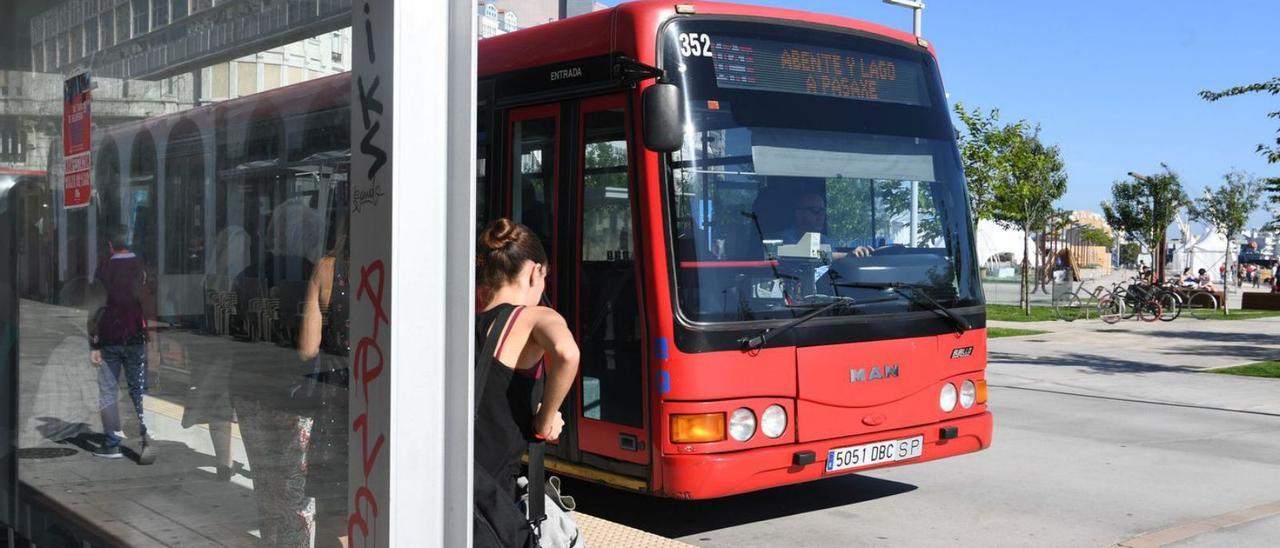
[991, 127, 1066, 315]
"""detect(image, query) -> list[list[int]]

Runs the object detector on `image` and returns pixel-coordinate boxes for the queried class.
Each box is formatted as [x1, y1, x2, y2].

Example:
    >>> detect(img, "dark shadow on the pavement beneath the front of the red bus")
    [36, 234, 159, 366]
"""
[563, 475, 916, 538]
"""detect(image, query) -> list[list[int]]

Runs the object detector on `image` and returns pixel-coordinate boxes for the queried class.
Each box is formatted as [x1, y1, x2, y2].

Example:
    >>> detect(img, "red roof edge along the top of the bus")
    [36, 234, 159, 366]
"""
[476, 0, 933, 78]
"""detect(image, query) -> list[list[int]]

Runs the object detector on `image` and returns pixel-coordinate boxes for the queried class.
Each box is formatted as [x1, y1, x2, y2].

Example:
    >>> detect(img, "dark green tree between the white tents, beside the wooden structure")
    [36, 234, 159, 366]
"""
[1102, 166, 1188, 278]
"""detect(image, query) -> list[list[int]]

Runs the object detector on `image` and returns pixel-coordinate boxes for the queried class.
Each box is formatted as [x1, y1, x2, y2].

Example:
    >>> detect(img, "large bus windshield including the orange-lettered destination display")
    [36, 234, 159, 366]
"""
[662, 19, 982, 323]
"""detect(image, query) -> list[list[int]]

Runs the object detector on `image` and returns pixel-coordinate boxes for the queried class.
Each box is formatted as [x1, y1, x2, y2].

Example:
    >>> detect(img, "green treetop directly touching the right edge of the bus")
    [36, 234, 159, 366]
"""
[955, 102, 1027, 224]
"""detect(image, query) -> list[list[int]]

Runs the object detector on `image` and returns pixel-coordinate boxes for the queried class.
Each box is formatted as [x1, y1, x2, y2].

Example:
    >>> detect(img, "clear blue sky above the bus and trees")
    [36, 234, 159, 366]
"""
[607, 0, 1280, 225]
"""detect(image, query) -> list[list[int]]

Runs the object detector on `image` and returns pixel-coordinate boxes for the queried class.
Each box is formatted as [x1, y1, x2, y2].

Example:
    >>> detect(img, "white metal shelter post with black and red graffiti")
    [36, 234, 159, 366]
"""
[348, 0, 475, 547]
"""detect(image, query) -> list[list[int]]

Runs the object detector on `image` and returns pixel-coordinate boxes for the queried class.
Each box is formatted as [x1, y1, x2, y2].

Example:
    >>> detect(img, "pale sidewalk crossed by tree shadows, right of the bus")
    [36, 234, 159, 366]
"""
[987, 308, 1280, 416]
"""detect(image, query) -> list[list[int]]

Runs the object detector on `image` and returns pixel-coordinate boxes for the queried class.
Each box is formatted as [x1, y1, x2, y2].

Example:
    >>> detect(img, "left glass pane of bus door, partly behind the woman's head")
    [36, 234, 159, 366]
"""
[507, 105, 559, 302]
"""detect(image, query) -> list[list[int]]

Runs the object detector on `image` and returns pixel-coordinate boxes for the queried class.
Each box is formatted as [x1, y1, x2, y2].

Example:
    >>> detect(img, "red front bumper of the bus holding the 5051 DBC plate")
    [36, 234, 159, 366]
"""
[660, 411, 992, 499]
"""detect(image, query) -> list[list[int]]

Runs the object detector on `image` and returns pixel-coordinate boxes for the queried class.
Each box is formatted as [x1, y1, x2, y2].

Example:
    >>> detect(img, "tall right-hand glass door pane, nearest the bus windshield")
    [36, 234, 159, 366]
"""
[577, 96, 648, 462]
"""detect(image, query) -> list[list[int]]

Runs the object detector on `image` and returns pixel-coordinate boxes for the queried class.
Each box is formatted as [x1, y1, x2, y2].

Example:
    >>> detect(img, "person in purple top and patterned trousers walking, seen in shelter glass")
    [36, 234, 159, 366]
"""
[88, 227, 156, 465]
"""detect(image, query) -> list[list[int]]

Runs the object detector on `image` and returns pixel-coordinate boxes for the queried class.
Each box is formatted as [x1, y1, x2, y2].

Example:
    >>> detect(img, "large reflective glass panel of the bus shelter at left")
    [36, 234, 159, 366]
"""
[0, 19, 351, 547]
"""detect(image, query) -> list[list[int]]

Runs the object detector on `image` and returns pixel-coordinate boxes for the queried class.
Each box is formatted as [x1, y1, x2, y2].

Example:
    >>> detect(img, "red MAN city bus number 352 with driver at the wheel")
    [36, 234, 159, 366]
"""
[477, 1, 992, 498]
